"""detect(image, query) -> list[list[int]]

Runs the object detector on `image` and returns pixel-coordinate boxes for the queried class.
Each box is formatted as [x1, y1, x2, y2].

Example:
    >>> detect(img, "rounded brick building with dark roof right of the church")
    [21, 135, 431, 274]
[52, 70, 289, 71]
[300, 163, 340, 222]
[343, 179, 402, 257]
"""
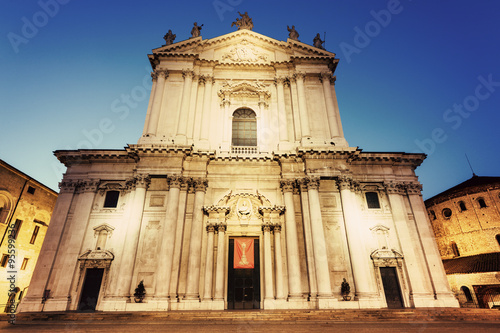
[425, 175, 500, 308]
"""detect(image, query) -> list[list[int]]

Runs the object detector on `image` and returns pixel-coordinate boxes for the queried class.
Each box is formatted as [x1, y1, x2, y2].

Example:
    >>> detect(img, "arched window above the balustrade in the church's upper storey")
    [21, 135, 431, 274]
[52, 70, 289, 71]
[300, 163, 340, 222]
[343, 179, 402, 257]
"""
[232, 109, 257, 146]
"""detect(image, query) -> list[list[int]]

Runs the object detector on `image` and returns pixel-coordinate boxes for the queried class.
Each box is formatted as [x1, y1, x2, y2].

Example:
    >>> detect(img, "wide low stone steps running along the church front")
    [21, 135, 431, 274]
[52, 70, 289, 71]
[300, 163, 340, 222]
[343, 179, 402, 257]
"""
[0, 308, 500, 324]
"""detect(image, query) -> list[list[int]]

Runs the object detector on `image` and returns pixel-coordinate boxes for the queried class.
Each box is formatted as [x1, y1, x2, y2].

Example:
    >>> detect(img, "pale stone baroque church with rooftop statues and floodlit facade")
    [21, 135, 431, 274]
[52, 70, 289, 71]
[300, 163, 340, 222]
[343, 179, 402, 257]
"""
[21, 15, 458, 312]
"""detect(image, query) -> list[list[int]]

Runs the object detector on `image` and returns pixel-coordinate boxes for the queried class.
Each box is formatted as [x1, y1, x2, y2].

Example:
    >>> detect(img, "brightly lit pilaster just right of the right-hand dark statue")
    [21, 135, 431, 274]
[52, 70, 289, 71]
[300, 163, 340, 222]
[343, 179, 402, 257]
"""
[337, 177, 374, 299]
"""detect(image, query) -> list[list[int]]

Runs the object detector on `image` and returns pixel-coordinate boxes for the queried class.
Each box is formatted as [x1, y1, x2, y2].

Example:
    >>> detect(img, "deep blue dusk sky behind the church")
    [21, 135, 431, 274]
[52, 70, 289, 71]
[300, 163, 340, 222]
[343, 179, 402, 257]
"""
[0, 0, 500, 199]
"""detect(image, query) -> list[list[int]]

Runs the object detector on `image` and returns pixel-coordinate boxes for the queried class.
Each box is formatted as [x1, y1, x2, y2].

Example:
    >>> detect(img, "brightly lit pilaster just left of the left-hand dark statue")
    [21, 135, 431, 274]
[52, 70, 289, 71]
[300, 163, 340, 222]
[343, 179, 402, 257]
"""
[117, 174, 150, 297]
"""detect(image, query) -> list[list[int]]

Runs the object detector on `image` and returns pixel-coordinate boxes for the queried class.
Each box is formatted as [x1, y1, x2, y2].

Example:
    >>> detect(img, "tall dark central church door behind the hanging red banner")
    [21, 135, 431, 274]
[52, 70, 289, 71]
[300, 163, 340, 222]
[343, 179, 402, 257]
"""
[227, 237, 260, 309]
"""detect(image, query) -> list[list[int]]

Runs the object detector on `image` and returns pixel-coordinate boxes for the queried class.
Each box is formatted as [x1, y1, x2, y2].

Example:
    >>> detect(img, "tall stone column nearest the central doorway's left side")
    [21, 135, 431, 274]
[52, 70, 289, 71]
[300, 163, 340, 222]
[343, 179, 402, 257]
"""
[184, 179, 208, 299]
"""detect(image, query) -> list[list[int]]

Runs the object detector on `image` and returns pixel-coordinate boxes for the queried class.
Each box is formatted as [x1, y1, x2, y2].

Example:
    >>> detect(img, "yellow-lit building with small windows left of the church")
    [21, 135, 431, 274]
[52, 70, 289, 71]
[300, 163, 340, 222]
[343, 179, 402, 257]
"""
[0, 160, 57, 312]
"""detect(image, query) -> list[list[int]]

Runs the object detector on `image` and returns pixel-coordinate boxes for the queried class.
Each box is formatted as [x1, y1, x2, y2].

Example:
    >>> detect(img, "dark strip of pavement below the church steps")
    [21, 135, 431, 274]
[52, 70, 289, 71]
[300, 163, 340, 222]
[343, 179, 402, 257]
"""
[0, 321, 500, 333]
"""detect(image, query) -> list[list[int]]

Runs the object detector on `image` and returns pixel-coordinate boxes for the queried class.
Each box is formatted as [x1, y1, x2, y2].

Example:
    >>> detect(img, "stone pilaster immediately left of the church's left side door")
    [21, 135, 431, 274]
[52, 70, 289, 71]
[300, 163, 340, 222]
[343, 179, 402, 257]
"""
[46, 179, 99, 311]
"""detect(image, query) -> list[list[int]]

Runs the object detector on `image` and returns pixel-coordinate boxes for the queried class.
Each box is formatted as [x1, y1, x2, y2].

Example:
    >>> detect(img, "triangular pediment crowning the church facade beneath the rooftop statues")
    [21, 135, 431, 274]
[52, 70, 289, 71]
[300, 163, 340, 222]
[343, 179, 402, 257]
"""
[149, 30, 335, 64]
